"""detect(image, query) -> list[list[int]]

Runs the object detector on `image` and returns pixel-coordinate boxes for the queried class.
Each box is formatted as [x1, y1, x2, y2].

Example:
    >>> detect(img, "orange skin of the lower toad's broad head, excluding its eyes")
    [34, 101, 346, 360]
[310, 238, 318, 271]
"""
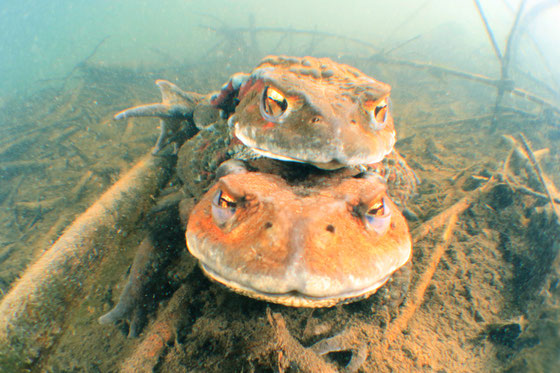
[186, 164, 411, 307]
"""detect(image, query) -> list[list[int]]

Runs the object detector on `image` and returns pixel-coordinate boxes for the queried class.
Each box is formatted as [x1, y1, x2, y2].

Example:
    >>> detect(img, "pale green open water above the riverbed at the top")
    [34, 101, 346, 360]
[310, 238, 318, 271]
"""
[0, 0, 560, 99]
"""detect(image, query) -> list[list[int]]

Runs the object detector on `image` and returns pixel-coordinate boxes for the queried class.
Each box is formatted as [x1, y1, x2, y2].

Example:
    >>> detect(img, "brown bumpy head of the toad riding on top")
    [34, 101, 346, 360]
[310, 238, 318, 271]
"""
[211, 56, 395, 169]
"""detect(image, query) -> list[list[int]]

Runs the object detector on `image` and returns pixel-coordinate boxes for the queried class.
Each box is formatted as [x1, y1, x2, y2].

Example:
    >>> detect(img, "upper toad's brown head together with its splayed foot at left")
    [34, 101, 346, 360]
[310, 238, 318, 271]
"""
[115, 56, 395, 169]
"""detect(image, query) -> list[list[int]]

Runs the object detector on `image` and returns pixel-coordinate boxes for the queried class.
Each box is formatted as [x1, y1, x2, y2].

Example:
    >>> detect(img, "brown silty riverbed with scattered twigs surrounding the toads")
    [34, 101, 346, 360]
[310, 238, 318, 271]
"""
[0, 59, 560, 372]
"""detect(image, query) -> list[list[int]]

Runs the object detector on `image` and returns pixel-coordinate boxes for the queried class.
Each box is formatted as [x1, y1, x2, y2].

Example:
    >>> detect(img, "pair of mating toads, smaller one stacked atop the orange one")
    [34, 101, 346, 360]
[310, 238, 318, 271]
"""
[109, 56, 414, 307]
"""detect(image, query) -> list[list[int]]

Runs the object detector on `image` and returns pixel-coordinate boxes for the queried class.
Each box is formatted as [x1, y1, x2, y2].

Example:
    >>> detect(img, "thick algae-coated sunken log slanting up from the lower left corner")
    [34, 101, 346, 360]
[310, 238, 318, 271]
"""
[0, 155, 171, 372]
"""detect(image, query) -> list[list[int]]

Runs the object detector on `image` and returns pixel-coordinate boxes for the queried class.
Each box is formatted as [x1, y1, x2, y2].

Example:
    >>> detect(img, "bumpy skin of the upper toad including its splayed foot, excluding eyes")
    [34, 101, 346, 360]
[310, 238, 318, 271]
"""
[104, 57, 416, 336]
